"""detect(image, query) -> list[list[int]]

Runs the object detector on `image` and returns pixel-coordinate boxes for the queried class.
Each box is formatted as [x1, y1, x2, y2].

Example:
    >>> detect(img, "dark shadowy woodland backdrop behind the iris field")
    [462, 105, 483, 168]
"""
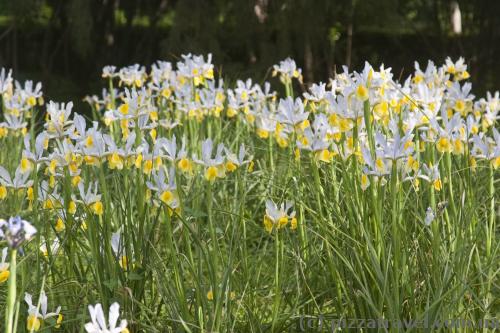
[0, 0, 500, 108]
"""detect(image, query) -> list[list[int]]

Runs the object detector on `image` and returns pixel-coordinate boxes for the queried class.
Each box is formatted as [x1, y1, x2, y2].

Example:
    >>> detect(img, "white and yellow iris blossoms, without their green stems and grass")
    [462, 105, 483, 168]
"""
[0, 54, 500, 332]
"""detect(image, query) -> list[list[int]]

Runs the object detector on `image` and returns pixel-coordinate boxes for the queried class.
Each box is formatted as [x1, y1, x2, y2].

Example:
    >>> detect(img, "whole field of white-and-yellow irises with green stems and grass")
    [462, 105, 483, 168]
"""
[0, 55, 500, 333]
